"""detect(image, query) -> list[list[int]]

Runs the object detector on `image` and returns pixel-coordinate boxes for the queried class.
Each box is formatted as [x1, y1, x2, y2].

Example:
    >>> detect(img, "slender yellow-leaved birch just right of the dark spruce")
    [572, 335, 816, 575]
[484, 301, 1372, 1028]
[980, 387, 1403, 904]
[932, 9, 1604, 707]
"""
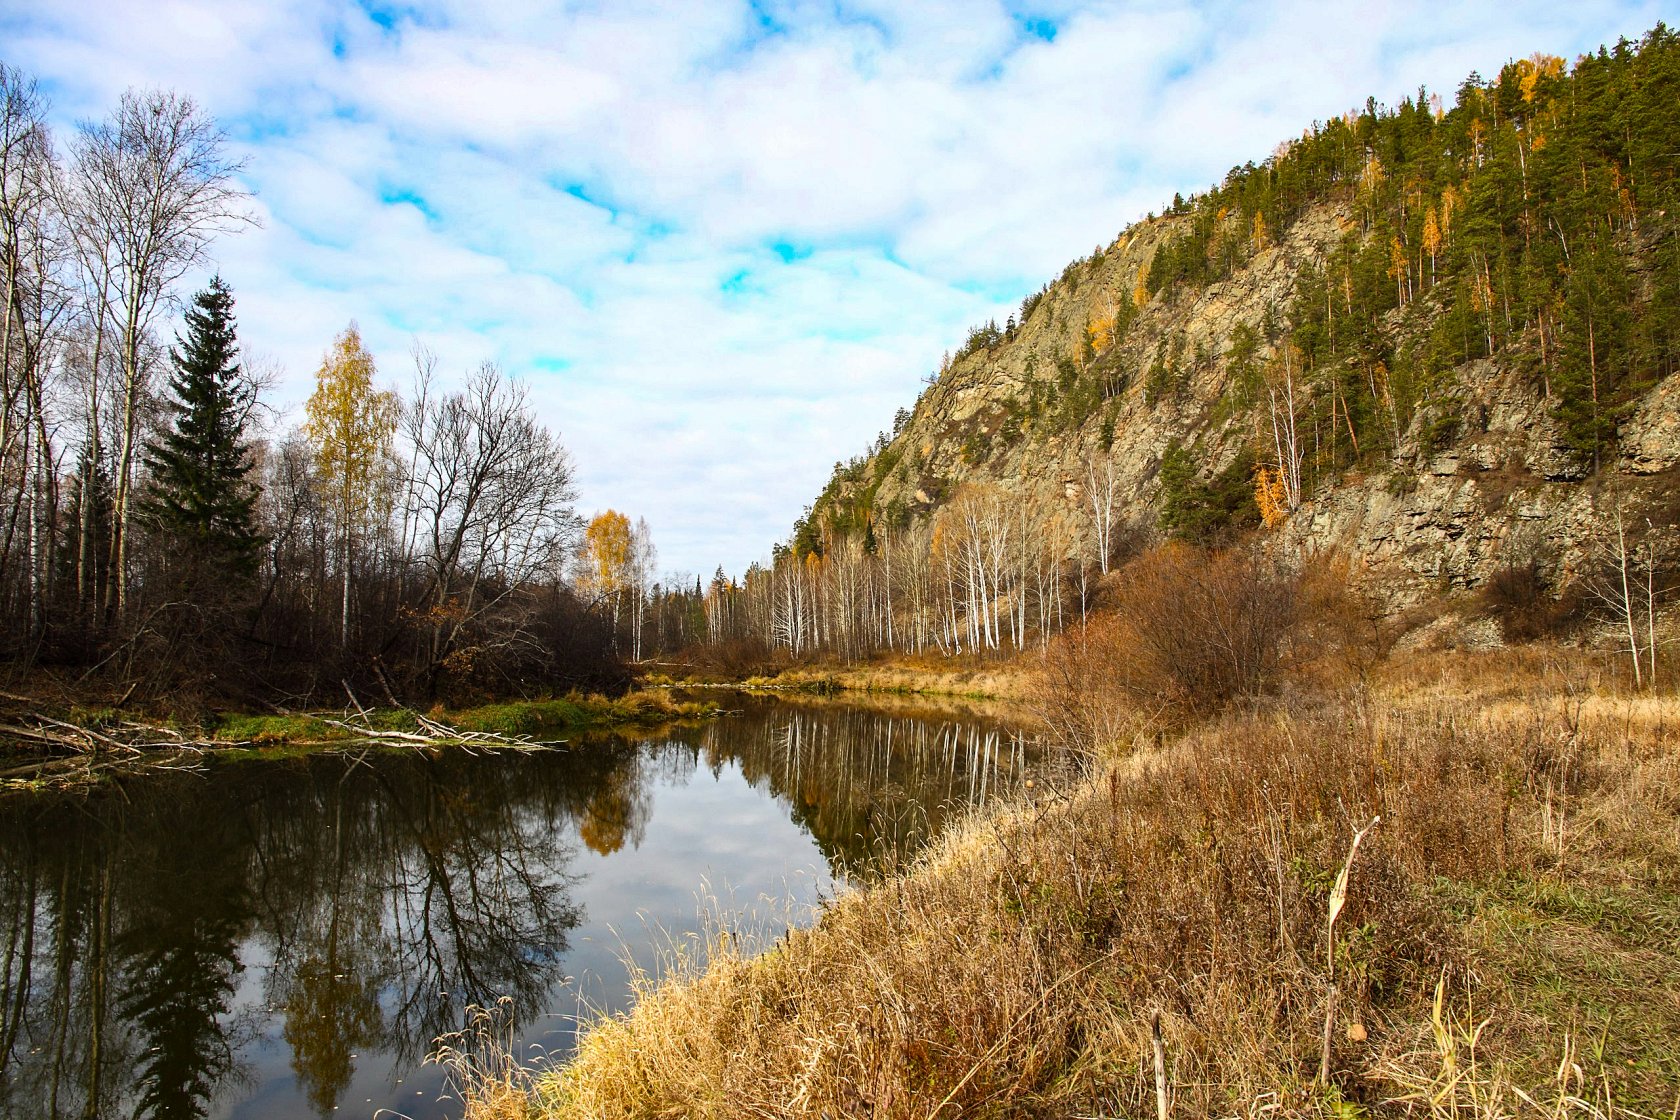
[304, 322, 402, 643]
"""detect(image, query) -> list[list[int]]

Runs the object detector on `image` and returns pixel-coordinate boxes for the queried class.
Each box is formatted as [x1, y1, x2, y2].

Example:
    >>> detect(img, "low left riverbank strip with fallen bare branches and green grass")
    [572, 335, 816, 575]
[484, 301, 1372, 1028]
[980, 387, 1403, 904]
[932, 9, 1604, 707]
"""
[0, 688, 717, 789]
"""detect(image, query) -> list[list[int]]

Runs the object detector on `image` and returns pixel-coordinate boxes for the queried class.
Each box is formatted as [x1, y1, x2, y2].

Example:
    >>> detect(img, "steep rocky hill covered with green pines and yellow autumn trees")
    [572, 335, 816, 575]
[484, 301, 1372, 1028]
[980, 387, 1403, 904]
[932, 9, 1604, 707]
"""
[783, 25, 1680, 596]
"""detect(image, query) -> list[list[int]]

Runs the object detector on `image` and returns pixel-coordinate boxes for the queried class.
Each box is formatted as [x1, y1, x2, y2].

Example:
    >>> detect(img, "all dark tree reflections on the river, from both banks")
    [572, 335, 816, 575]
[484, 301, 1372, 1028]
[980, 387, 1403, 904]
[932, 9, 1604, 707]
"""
[0, 705, 1025, 1120]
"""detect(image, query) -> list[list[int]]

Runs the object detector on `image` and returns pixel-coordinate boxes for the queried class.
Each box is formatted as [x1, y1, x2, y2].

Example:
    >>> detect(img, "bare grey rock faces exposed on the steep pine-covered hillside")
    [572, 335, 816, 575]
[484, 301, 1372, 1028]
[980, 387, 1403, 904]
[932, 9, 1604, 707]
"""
[829, 198, 1680, 604]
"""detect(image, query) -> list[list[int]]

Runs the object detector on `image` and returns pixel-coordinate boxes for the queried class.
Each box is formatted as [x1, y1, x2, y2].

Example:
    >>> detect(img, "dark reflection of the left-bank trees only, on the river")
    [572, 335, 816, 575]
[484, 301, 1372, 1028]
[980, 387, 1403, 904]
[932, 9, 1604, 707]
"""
[0, 749, 624, 1120]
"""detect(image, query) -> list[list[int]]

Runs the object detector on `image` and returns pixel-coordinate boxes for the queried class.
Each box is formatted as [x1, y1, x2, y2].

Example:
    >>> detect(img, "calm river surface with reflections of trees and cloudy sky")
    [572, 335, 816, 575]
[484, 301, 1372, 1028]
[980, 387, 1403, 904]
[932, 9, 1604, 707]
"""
[0, 699, 1035, 1120]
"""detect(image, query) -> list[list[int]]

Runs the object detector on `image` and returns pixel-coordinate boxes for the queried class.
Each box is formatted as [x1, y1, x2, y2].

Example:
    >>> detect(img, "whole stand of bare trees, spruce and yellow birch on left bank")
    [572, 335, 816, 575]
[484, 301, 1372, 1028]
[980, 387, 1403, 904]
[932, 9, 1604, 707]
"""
[0, 65, 623, 704]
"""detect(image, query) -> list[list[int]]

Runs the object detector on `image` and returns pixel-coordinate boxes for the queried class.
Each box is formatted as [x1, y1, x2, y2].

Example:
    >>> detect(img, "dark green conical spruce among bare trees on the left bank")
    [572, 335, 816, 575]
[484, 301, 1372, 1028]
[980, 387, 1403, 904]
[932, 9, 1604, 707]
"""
[141, 277, 262, 579]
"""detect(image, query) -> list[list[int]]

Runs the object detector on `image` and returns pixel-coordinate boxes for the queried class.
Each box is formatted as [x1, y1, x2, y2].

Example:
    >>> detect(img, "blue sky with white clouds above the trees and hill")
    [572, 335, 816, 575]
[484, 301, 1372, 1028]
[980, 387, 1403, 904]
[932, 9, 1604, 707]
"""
[0, 0, 1672, 573]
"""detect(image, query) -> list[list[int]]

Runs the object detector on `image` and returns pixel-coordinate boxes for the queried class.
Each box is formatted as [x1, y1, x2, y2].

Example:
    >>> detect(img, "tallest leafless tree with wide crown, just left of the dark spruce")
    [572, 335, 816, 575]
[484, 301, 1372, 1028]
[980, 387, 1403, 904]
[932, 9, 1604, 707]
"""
[69, 89, 252, 610]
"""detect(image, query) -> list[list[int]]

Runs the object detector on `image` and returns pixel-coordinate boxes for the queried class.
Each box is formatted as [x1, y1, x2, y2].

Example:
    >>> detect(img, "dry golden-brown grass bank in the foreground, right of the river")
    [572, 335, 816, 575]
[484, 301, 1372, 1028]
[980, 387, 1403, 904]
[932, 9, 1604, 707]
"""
[453, 653, 1680, 1118]
